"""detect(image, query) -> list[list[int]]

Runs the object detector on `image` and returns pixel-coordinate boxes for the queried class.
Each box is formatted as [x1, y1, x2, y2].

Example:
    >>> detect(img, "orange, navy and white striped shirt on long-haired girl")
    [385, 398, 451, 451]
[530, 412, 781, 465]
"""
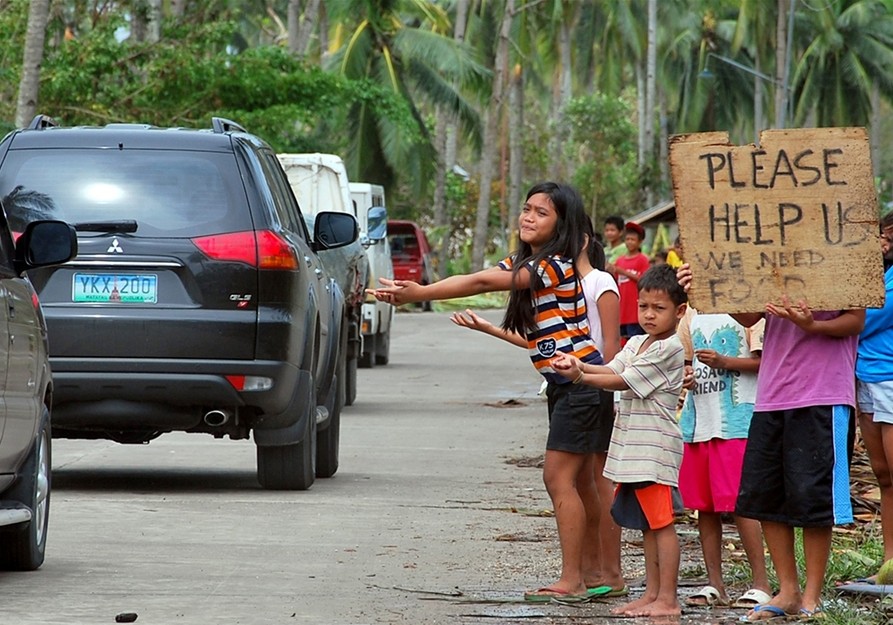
[499, 256, 602, 384]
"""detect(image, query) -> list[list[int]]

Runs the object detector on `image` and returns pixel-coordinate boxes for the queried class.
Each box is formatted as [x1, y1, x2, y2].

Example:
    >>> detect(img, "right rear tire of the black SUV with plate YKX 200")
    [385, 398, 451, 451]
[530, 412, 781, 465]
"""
[257, 394, 316, 490]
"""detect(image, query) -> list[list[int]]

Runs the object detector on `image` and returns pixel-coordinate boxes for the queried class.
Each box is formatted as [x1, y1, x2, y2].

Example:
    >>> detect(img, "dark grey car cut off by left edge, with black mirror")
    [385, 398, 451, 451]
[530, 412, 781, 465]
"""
[0, 212, 77, 570]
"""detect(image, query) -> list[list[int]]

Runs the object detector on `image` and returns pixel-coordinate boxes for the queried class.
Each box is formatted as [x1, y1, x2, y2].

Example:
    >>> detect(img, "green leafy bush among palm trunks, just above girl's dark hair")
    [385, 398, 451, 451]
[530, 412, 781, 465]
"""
[565, 94, 639, 223]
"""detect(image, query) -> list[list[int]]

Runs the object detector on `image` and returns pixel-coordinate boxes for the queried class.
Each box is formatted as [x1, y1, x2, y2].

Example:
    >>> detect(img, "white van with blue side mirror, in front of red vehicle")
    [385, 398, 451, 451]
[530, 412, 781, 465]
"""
[350, 182, 394, 367]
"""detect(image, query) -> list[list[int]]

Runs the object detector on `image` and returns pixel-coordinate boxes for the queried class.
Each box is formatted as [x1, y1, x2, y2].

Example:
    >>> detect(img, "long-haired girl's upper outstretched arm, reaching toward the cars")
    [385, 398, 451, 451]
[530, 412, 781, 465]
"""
[366, 267, 530, 305]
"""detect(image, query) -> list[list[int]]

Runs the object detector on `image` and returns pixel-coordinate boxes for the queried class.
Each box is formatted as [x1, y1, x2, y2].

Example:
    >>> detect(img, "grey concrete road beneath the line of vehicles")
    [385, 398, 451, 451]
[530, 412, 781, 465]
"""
[0, 313, 580, 625]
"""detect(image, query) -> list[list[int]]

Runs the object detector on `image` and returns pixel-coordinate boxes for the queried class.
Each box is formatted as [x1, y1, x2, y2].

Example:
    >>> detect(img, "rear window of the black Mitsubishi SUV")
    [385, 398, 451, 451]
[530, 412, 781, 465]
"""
[0, 148, 252, 237]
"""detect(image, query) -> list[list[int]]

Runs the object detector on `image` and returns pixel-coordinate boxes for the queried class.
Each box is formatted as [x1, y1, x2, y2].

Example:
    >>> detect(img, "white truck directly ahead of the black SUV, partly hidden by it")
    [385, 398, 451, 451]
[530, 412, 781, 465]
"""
[276, 153, 372, 406]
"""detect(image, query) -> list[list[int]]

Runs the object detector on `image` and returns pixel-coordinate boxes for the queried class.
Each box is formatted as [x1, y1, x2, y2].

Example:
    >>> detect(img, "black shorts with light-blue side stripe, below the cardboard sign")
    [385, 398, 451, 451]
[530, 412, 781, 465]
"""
[735, 406, 856, 527]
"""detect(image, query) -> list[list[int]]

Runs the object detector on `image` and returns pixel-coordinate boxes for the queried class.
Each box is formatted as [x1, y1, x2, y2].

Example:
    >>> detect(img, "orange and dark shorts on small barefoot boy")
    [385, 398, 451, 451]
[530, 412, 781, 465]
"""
[611, 482, 682, 531]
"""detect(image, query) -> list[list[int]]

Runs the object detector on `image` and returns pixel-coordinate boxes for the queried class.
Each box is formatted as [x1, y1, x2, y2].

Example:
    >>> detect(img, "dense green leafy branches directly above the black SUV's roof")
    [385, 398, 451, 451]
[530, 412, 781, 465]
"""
[4, 16, 414, 152]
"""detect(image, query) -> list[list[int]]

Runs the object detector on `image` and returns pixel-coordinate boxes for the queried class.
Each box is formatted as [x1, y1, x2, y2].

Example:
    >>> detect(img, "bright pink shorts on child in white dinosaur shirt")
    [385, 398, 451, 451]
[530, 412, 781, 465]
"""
[679, 438, 747, 512]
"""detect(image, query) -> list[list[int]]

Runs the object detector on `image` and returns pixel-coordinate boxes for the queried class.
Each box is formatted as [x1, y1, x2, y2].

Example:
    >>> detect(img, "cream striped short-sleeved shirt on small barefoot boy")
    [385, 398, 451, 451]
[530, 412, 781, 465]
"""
[604, 334, 685, 486]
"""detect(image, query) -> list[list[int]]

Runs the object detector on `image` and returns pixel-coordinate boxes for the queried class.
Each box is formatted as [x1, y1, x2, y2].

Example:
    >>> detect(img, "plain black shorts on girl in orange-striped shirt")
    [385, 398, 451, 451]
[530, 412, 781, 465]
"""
[546, 383, 614, 454]
